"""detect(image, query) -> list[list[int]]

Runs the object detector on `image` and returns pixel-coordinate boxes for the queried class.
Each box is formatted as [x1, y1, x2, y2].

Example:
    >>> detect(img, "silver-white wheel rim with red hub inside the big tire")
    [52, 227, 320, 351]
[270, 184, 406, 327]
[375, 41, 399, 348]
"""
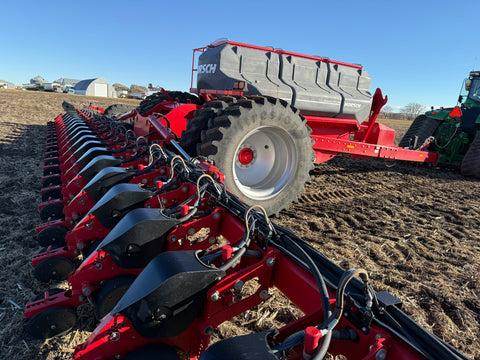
[233, 126, 298, 200]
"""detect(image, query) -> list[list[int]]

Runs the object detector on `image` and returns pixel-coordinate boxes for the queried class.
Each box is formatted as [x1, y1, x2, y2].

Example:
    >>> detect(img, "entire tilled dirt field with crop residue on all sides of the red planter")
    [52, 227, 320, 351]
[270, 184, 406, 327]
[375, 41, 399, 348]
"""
[0, 89, 480, 360]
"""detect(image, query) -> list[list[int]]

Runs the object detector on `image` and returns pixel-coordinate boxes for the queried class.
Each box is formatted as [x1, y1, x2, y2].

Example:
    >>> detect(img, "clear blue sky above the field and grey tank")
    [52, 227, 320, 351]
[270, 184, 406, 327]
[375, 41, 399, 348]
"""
[0, 0, 480, 109]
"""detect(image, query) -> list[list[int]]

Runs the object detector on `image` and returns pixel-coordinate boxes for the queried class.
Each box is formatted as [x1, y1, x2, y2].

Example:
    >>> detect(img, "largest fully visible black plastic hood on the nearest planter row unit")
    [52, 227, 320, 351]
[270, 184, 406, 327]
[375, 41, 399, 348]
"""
[111, 251, 225, 339]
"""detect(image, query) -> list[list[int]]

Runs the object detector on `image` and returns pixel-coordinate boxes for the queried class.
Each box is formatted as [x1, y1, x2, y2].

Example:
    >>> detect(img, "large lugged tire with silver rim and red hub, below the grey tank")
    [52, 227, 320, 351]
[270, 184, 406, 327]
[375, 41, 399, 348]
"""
[200, 96, 314, 215]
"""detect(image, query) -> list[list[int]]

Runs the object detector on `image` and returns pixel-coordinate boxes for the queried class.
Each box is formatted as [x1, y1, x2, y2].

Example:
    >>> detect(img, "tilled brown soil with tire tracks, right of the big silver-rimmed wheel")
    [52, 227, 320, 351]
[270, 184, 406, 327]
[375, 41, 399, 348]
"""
[280, 158, 480, 358]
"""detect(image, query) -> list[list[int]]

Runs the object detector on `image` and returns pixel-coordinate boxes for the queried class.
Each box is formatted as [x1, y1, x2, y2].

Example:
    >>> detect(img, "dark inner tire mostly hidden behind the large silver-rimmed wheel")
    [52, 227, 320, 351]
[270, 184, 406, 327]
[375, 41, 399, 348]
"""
[180, 96, 237, 156]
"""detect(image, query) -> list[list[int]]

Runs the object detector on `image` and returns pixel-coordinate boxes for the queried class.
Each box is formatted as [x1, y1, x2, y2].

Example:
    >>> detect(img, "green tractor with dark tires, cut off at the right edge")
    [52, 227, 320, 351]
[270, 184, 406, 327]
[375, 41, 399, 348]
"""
[399, 71, 480, 178]
